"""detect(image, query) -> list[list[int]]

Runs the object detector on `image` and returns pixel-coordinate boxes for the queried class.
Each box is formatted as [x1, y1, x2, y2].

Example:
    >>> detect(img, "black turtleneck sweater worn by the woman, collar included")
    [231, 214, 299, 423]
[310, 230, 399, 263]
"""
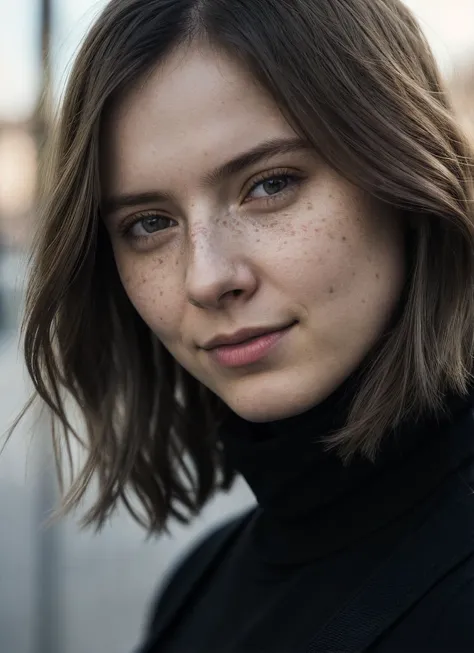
[135, 385, 474, 653]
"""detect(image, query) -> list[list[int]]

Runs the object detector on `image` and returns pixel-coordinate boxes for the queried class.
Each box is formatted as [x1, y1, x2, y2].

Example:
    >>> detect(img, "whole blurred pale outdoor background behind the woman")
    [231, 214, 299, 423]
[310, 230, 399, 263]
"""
[0, 0, 474, 653]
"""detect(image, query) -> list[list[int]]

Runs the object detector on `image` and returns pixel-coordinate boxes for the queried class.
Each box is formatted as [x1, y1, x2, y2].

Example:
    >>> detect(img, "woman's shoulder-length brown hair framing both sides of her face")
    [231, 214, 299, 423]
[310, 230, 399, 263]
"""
[17, 0, 474, 531]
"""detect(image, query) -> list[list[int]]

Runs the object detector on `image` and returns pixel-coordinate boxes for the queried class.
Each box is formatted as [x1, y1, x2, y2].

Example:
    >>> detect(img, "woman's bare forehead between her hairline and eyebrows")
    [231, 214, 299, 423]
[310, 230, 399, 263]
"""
[103, 46, 294, 191]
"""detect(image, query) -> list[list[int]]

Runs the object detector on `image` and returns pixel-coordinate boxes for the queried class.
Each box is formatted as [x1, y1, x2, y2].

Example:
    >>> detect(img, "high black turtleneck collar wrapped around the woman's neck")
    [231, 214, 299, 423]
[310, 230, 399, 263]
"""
[222, 378, 474, 564]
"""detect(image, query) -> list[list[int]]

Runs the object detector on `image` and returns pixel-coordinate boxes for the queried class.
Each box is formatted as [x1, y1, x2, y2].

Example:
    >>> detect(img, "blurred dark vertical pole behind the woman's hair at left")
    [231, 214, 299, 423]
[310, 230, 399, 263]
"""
[34, 0, 64, 653]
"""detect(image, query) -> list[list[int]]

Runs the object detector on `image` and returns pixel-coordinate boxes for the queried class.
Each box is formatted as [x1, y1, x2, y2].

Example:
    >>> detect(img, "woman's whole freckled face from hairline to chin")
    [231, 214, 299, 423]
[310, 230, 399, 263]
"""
[101, 46, 404, 421]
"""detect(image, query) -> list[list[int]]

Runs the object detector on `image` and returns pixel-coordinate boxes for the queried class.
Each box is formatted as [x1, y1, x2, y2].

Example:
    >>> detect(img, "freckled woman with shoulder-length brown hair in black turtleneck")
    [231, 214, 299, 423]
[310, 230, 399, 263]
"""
[17, 0, 474, 653]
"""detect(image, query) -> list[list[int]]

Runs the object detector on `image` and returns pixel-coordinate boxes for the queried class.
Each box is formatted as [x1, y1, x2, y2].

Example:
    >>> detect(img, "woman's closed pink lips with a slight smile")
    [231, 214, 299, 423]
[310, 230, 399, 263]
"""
[203, 322, 296, 367]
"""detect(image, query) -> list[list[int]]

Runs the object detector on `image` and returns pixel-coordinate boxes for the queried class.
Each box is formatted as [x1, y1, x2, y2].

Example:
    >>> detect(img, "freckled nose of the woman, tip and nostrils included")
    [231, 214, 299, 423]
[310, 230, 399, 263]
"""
[186, 227, 258, 309]
